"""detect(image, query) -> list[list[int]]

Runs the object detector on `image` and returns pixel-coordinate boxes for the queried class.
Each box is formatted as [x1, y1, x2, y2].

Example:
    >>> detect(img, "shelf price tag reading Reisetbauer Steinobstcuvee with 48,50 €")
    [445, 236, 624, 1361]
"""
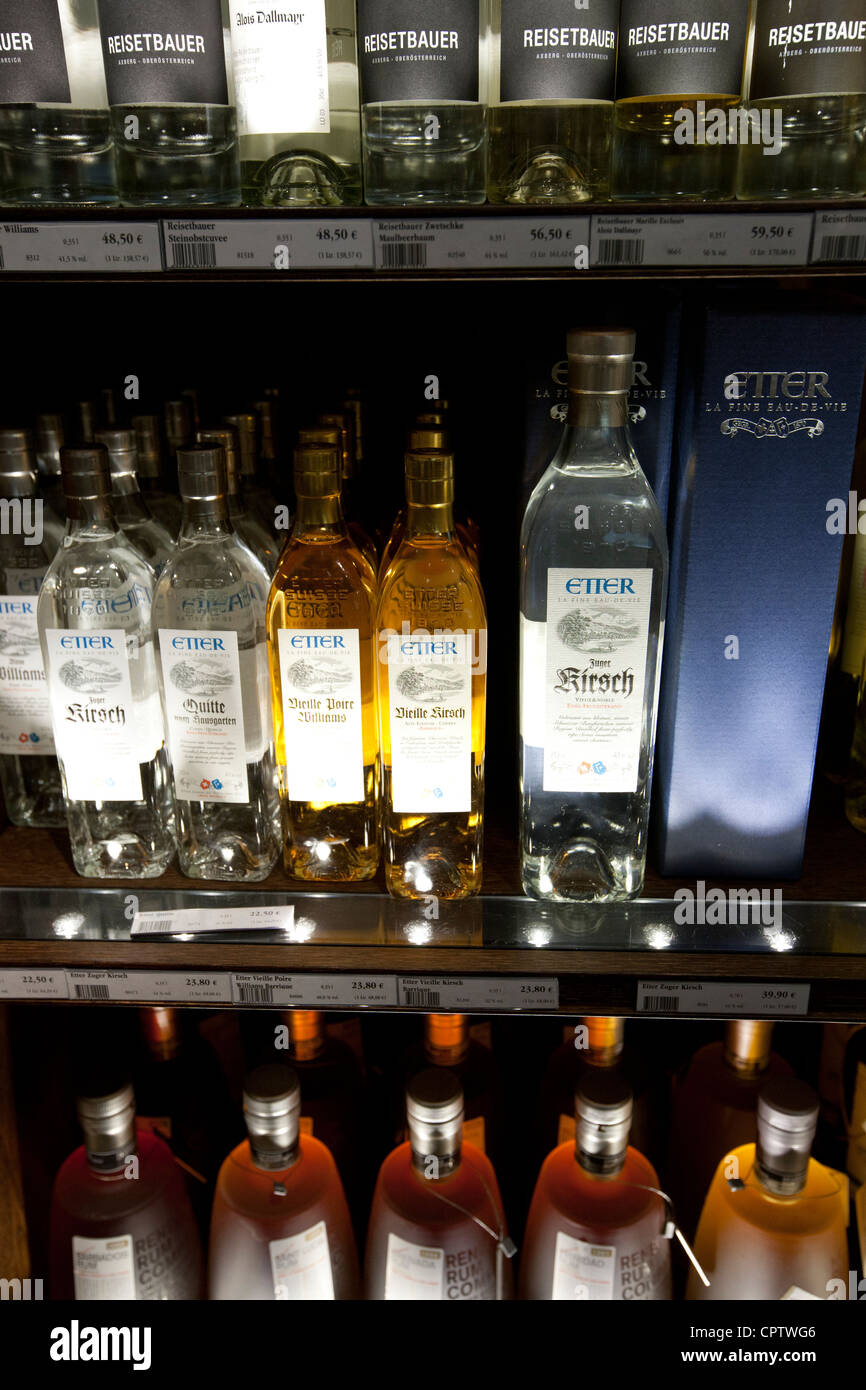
[163, 217, 373, 271]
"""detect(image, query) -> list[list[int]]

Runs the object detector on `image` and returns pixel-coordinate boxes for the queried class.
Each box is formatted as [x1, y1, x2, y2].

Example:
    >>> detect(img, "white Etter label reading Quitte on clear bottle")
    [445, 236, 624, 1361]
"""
[160, 627, 255, 803]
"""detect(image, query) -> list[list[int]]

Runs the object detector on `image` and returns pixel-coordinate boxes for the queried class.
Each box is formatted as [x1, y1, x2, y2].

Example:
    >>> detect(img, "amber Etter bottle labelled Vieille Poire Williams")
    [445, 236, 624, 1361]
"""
[267, 445, 379, 881]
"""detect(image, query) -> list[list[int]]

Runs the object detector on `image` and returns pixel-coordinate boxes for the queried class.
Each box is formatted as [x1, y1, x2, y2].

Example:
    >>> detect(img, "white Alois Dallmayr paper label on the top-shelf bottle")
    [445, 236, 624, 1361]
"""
[229, 0, 331, 135]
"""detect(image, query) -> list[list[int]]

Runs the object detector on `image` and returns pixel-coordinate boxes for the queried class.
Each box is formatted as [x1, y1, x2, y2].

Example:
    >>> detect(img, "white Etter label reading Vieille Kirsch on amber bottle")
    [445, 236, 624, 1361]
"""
[388, 632, 484, 813]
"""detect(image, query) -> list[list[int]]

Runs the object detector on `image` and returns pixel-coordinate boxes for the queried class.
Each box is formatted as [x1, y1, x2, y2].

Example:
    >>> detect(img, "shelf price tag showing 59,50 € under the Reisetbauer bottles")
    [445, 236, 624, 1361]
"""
[589, 213, 812, 270]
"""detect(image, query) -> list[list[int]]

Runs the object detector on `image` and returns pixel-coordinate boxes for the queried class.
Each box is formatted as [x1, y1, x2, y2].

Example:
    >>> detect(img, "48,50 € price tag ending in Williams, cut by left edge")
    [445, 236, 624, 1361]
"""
[0, 222, 163, 275]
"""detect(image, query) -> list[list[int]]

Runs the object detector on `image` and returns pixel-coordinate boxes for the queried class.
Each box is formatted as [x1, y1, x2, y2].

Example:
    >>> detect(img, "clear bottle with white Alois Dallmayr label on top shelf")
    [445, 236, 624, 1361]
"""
[229, 0, 361, 207]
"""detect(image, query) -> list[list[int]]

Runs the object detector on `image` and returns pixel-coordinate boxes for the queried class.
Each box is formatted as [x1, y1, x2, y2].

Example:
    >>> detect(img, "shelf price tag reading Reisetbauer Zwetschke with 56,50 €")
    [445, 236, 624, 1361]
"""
[374, 215, 589, 270]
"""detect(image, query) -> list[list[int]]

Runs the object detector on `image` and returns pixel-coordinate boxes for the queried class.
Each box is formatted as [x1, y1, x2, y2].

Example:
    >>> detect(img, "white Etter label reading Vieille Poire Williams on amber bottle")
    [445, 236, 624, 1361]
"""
[277, 627, 364, 802]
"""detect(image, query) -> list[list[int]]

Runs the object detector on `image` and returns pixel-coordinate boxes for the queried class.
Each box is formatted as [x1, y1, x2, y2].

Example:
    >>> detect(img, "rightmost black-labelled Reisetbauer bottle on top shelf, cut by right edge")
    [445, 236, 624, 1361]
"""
[737, 0, 866, 201]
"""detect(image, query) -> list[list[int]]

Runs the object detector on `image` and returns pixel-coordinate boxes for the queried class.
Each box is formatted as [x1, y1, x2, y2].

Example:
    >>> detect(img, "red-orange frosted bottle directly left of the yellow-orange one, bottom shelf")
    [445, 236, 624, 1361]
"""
[520, 1070, 671, 1302]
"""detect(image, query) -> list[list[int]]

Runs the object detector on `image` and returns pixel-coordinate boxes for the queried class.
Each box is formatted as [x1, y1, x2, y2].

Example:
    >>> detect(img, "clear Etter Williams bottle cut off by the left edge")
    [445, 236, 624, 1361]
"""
[0, 430, 67, 826]
